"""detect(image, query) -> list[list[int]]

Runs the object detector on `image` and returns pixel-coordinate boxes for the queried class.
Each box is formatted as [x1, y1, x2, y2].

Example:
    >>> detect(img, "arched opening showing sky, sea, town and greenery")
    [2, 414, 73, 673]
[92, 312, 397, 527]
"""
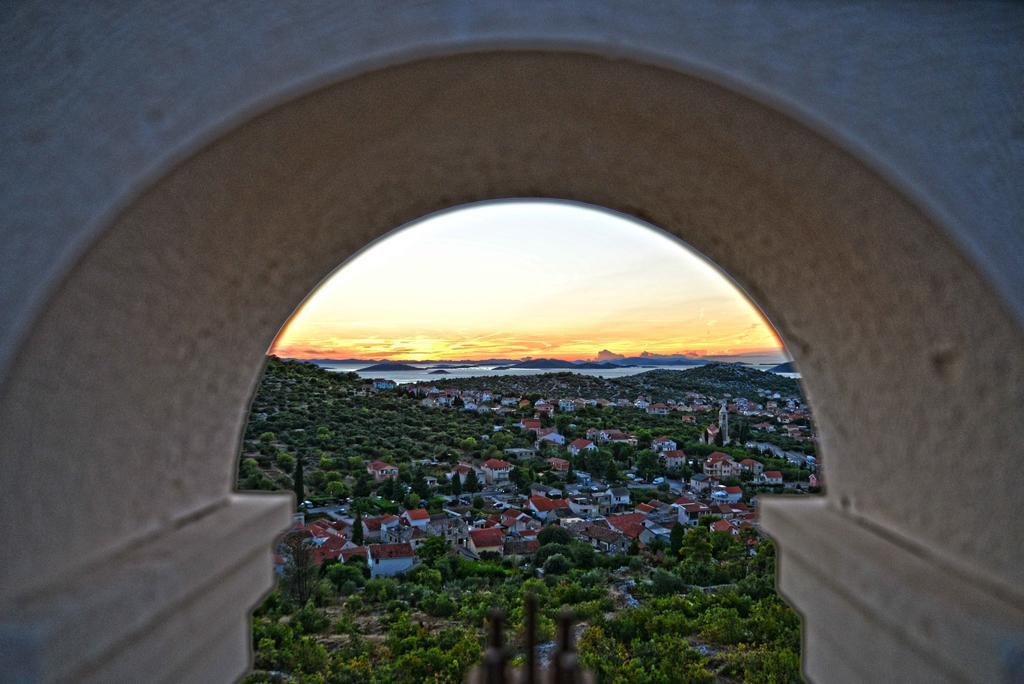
[239, 200, 822, 681]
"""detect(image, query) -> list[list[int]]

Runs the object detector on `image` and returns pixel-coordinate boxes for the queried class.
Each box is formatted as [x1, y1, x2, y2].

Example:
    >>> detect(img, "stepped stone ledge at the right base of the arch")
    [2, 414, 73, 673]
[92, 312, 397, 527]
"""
[762, 498, 1024, 682]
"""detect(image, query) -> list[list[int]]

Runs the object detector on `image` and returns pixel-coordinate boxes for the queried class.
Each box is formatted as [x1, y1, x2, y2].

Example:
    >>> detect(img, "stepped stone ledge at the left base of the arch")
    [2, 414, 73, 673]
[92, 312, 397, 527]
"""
[0, 495, 293, 682]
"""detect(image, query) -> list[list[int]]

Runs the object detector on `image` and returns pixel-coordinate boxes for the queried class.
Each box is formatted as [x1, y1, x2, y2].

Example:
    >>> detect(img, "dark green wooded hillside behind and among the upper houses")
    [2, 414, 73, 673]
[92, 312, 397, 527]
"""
[239, 358, 814, 500]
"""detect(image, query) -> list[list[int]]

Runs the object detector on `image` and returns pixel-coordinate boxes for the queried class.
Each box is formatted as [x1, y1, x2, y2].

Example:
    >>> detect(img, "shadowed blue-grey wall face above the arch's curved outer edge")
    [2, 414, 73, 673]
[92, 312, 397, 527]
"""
[0, 0, 1024, 375]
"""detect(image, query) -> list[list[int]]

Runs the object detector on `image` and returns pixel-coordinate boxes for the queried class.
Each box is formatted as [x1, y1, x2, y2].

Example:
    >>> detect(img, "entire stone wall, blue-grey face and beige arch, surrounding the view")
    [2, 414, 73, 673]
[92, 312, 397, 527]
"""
[0, 2, 1024, 680]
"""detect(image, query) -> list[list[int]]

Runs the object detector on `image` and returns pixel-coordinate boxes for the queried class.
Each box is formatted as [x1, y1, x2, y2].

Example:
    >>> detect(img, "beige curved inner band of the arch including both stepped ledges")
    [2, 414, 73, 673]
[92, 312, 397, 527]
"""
[0, 6, 1024, 681]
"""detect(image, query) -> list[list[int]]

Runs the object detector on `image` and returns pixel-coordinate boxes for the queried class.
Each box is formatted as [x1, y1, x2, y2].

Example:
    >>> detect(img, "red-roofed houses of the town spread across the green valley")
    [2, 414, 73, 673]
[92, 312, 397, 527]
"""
[281, 379, 821, 576]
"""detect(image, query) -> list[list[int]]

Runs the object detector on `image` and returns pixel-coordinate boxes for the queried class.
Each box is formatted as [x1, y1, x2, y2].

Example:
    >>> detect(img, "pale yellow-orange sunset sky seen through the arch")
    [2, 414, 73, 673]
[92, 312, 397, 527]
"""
[270, 201, 782, 360]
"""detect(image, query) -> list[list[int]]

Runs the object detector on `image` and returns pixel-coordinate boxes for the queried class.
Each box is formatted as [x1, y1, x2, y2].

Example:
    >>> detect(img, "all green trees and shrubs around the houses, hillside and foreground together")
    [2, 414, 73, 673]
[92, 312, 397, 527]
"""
[239, 359, 807, 684]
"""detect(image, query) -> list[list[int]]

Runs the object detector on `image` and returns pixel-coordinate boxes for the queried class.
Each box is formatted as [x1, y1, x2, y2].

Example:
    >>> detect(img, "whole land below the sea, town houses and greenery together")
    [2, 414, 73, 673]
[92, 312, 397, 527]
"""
[239, 358, 822, 682]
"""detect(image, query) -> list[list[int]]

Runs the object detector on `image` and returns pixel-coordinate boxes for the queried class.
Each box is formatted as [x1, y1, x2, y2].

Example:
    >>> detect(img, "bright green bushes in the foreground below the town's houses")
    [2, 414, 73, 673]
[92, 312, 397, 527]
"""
[241, 527, 800, 684]
